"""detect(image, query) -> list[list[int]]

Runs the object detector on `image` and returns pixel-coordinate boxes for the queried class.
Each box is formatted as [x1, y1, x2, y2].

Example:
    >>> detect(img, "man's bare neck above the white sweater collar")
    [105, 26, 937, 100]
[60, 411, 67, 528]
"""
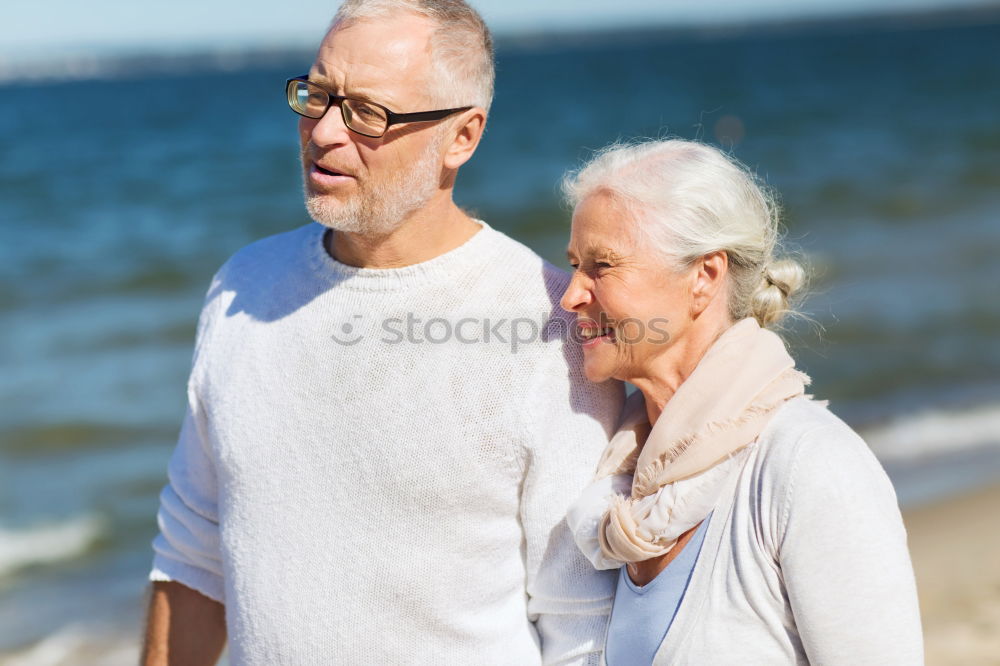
[325, 196, 481, 268]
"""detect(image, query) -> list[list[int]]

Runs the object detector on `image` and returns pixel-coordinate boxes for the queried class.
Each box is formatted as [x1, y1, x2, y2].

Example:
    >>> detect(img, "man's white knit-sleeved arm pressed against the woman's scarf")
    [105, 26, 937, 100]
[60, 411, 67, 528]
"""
[521, 342, 623, 666]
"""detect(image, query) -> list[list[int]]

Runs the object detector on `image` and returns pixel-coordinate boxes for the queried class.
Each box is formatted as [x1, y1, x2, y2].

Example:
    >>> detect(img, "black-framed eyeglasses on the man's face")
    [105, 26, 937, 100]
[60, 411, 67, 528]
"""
[285, 76, 472, 138]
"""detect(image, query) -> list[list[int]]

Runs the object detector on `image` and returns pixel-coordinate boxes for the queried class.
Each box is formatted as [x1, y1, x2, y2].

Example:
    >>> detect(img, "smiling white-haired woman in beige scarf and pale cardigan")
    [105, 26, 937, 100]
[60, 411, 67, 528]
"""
[561, 140, 923, 666]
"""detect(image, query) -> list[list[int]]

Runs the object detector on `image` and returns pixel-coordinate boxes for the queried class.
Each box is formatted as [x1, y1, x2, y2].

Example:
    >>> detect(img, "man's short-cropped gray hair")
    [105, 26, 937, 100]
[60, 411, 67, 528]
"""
[331, 0, 494, 111]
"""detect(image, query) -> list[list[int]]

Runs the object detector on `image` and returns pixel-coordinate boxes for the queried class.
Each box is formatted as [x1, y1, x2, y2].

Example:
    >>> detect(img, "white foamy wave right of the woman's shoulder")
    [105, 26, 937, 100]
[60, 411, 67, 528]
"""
[861, 404, 1000, 462]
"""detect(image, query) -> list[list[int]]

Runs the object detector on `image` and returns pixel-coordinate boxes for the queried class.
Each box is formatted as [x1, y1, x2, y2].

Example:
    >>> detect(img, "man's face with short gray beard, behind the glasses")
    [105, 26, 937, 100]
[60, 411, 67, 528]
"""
[299, 13, 447, 235]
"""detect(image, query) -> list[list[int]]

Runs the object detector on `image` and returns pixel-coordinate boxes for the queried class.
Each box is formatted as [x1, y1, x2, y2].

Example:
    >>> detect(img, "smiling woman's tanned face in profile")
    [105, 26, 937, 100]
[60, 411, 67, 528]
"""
[560, 192, 693, 382]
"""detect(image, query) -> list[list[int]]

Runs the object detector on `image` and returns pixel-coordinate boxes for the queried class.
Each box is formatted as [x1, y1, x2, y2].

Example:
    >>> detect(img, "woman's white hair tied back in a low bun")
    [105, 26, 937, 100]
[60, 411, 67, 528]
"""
[563, 139, 806, 326]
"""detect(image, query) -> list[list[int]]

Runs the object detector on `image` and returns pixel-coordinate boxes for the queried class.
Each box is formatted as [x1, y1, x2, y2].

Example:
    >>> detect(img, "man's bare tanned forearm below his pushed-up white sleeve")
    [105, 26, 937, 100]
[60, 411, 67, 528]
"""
[141, 582, 226, 666]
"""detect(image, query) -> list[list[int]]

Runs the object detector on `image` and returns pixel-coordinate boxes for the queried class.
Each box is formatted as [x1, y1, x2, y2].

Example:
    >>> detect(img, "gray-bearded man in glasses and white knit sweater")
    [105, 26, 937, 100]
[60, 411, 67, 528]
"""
[144, 0, 622, 665]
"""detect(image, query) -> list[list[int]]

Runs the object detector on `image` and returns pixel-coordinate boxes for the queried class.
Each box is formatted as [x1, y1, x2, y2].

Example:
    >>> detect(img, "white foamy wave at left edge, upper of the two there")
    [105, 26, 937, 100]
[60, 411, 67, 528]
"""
[0, 515, 106, 579]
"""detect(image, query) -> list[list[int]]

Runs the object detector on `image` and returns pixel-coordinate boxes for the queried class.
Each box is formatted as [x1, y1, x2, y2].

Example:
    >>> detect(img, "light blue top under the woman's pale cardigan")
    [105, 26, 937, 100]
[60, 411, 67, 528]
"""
[604, 515, 711, 666]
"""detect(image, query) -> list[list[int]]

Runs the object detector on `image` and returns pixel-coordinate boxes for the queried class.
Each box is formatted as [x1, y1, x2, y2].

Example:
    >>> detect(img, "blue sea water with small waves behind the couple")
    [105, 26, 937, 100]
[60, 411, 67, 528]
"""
[0, 16, 1000, 664]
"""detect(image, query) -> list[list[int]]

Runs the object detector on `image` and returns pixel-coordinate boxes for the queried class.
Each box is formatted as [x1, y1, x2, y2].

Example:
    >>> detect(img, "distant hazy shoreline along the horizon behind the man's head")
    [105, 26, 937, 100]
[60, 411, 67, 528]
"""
[0, 4, 1000, 84]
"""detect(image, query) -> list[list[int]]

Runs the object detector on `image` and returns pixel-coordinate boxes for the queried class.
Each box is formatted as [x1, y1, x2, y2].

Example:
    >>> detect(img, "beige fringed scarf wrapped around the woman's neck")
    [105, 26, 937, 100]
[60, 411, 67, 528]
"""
[595, 318, 810, 562]
